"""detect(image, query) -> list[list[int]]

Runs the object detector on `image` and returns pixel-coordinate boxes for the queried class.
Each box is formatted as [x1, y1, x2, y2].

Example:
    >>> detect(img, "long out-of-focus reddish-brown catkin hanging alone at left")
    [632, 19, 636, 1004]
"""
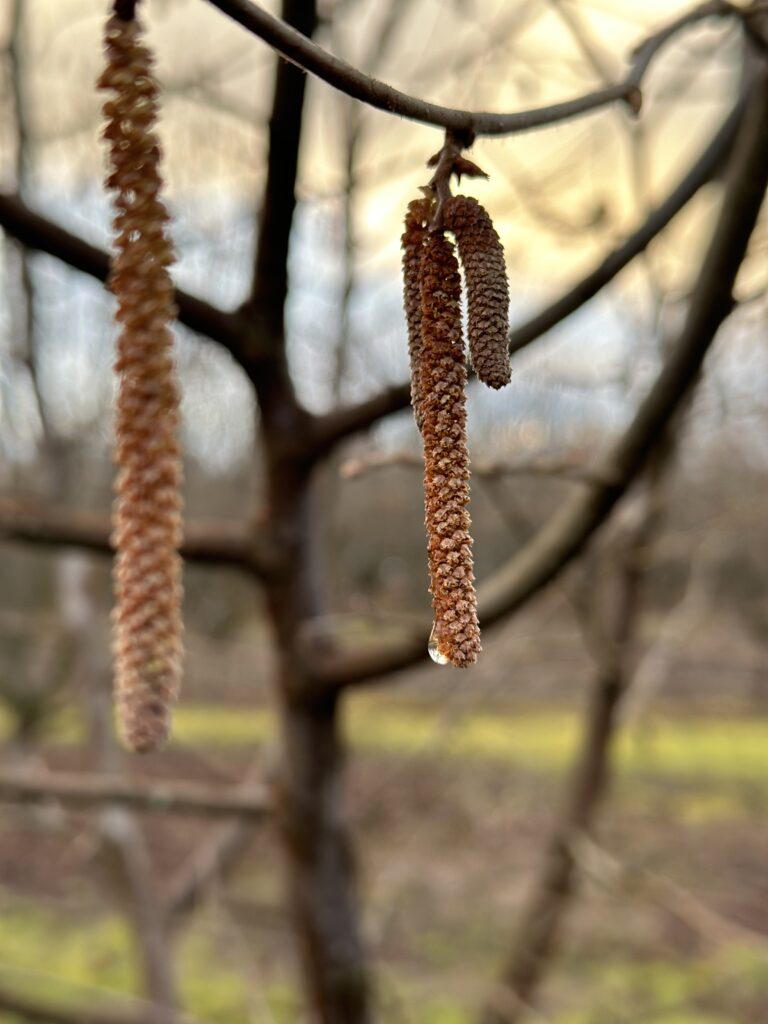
[98, 16, 182, 753]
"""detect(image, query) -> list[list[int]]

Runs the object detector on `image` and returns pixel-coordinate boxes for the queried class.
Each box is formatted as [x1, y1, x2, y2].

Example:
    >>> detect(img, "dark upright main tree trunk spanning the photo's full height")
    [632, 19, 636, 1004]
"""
[244, 0, 369, 1024]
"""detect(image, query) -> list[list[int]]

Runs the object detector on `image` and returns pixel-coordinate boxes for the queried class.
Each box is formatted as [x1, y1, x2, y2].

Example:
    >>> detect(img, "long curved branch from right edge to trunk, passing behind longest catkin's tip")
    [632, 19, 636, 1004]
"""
[305, 65, 768, 694]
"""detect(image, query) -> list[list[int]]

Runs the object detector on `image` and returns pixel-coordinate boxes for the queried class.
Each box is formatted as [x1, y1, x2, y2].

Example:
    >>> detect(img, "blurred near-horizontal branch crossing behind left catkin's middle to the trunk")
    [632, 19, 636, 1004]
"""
[0, 501, 278, 580]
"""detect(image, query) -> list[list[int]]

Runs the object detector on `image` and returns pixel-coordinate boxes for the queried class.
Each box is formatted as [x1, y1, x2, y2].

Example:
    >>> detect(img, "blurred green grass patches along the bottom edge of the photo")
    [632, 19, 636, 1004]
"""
[0, 901, 768, 1024]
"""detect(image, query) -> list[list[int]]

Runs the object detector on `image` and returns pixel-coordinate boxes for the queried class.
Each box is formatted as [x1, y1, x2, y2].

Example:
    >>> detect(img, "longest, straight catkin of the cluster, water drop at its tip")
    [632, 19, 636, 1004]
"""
[419, 231, 480, 668]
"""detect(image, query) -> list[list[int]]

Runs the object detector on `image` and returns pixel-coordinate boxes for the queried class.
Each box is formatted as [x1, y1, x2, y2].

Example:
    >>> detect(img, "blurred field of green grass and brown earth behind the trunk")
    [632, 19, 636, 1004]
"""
[0, 693, 768, 1024]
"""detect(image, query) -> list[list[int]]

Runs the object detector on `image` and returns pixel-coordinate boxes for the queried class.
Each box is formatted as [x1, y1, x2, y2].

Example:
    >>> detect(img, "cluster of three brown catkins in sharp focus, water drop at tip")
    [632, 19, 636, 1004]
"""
[402, 196, 511, 668]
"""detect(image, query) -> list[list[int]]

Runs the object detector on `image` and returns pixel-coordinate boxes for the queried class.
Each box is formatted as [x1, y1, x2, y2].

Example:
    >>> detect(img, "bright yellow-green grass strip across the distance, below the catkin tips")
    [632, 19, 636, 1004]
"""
[6, 695, 768, 785]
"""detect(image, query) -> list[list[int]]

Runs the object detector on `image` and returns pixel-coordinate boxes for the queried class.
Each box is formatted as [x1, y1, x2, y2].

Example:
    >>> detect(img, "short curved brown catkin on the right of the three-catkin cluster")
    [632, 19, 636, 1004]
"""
[442, 196, 511, 388]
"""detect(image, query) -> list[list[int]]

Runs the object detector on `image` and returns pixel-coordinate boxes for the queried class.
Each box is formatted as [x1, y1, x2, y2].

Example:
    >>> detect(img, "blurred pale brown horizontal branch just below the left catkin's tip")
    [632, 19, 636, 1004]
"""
[0, 772, 272, 820]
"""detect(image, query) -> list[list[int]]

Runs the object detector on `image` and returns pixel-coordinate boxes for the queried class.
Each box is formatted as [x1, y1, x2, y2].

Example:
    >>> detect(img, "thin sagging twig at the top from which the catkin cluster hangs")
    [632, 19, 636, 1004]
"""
[202, 0, 741, 136]
